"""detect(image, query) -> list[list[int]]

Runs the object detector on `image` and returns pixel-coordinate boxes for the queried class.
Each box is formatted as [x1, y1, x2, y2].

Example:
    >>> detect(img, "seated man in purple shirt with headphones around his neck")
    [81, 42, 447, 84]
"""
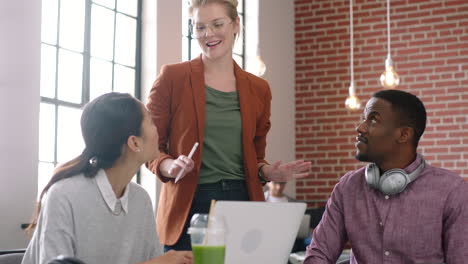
[304, 90, 468, 264]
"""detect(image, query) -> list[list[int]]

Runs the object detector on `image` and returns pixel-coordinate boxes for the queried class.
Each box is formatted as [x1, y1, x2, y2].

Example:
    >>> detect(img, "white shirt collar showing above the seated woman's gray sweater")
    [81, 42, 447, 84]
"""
[95, 170, 129, 215]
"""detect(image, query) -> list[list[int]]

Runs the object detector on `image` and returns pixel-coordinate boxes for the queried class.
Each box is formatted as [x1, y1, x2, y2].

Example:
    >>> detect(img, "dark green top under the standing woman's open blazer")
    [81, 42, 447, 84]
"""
[198, 85, 245, 184]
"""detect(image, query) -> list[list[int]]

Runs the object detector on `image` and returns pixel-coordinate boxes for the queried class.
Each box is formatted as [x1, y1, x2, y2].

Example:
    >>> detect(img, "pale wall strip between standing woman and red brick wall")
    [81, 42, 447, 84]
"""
[258, 0, 296, 197]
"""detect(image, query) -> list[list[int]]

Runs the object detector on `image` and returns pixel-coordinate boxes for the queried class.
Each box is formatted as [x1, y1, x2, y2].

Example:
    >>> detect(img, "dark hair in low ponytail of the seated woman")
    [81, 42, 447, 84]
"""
[26, 92, 143, 231]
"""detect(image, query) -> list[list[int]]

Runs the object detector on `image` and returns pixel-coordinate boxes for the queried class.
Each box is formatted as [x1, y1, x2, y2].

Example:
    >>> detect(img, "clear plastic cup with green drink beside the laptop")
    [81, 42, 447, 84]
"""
[187, 214, 226, 264]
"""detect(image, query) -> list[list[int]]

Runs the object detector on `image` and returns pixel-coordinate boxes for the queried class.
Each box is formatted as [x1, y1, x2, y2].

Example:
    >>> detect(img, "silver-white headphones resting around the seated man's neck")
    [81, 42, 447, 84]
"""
[366, 156, 426, 195]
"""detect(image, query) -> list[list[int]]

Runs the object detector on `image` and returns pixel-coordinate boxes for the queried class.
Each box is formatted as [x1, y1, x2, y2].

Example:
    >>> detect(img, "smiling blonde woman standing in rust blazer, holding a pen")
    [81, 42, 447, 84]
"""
[147, 0, 310, 250]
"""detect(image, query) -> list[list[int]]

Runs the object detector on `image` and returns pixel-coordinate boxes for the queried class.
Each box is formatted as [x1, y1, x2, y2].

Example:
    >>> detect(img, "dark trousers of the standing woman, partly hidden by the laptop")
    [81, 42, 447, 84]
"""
[164, 180, 249, 252]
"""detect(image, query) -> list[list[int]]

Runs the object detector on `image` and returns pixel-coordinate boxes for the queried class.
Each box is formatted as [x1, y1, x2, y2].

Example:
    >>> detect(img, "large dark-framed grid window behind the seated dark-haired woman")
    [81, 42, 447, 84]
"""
[38, 0, 141, 191]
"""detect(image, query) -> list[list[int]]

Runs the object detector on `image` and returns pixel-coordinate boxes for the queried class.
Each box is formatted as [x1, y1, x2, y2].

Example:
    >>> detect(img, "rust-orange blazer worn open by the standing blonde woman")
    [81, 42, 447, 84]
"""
[146, 56, 271, 245]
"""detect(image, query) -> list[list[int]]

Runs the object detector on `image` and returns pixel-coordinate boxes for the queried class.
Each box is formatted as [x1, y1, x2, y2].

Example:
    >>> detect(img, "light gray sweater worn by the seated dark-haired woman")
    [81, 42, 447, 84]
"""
[22, 170, 161, 264]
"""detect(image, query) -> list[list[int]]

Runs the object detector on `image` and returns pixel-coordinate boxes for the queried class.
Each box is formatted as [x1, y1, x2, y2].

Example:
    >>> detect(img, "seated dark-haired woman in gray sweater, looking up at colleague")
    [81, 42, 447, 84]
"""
[22, 93, 192, 264]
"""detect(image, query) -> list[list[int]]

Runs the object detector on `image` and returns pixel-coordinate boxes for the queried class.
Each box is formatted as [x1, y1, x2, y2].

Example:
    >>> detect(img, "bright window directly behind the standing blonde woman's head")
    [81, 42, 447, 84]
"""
[182, 0, 245, 66]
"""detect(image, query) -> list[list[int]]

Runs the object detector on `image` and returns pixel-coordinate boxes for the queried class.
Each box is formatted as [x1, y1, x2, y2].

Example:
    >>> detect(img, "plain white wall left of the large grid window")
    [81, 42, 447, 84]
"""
[0, 0, 41, 249]
